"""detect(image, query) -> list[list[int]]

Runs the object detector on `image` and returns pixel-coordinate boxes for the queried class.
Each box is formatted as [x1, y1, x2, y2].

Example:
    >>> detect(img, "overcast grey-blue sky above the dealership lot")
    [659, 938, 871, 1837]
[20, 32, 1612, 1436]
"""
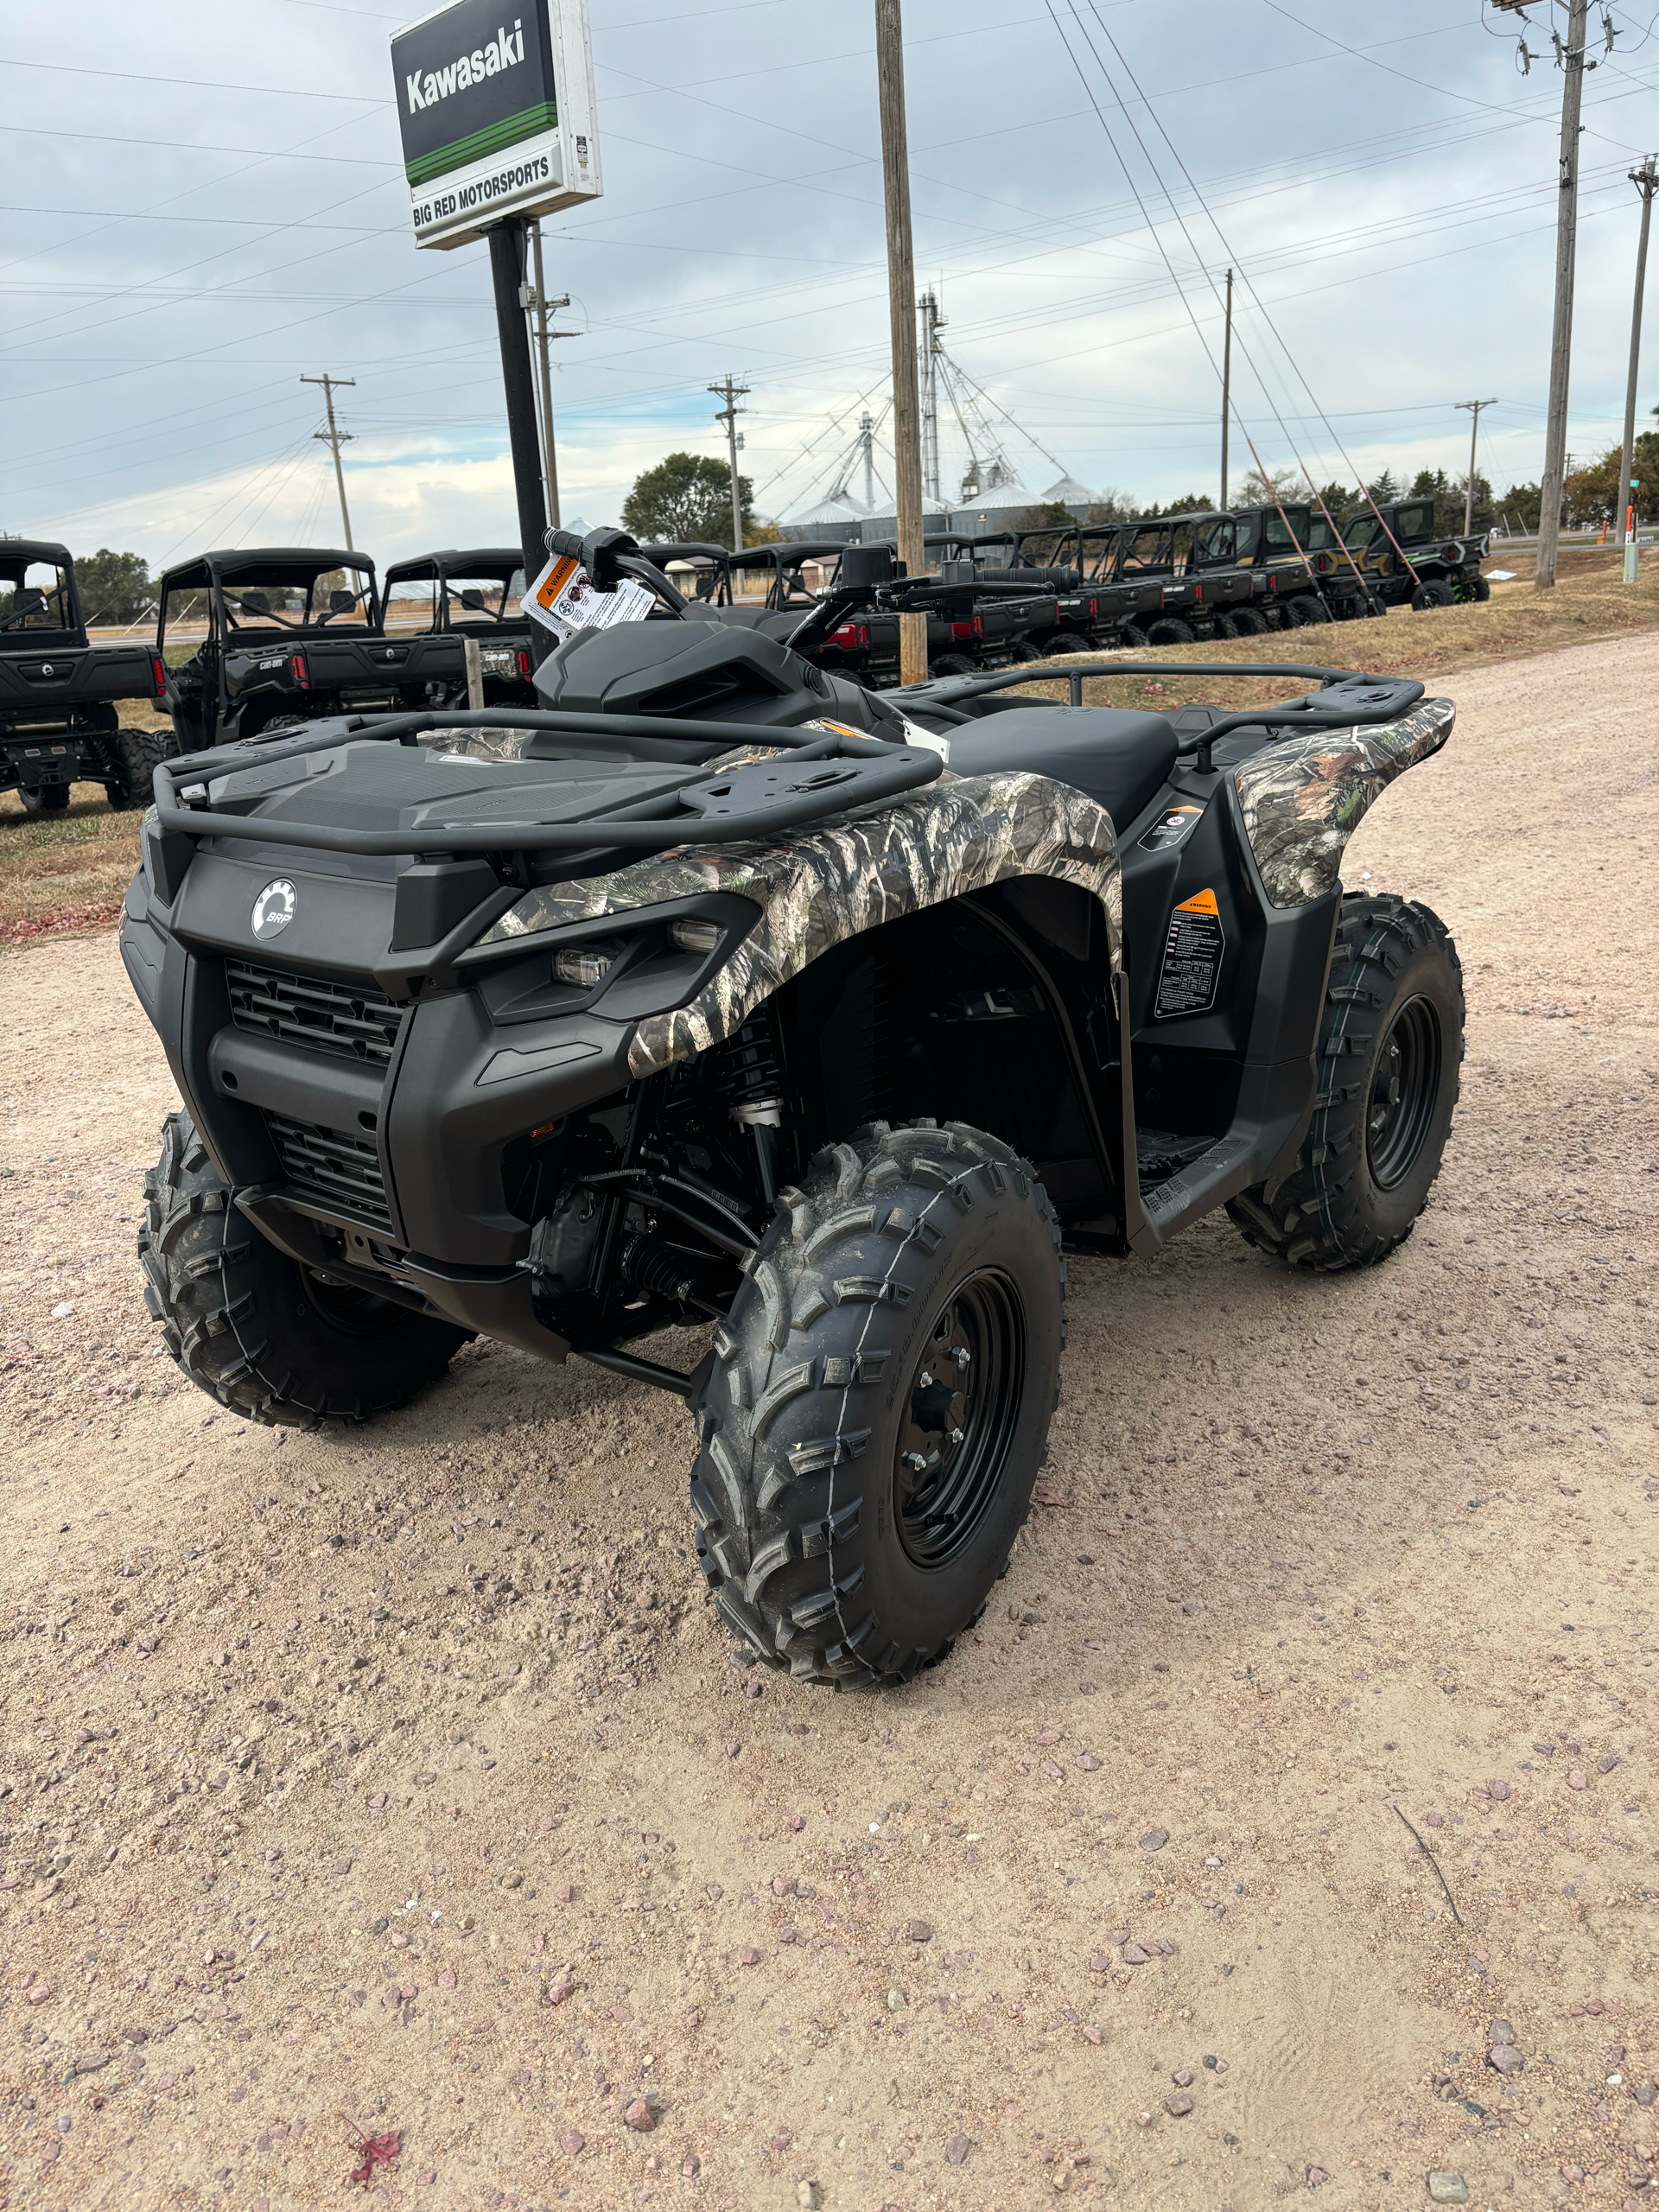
[0, 0, 1659, 566]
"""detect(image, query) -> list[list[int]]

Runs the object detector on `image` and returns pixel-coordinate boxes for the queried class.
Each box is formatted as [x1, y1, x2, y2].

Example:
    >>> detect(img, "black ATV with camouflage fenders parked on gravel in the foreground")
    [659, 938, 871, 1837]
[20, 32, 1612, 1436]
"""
[122, 531, 1462, 1686]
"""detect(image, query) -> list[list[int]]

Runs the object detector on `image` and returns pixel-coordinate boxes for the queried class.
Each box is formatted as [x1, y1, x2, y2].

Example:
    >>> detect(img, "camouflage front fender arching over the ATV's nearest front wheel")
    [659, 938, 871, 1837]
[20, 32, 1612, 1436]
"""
[480, 772, 1123, 1077]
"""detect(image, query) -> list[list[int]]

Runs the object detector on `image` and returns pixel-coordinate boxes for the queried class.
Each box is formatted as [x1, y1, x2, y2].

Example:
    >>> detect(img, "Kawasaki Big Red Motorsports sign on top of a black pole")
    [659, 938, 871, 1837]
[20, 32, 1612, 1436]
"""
[391, 0, 601, 245]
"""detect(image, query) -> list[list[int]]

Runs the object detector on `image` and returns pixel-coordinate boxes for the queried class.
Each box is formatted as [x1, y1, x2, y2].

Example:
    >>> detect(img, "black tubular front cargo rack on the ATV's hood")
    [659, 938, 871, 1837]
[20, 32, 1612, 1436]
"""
[155, 708, 944, 856]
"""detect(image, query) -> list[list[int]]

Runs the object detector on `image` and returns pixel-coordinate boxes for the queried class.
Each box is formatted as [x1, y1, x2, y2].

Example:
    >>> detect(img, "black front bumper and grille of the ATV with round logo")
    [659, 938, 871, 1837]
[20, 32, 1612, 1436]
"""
[122, 852, 716, 1358]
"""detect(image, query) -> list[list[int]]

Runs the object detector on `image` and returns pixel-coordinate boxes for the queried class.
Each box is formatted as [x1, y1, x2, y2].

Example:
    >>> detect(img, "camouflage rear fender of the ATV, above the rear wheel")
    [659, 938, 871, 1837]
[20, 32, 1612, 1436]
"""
[1232, 699, 1458, 907]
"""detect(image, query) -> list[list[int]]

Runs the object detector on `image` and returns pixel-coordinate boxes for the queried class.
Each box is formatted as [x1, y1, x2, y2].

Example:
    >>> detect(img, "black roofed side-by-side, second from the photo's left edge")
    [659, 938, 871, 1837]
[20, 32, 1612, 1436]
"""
[155, 546, 465, 747]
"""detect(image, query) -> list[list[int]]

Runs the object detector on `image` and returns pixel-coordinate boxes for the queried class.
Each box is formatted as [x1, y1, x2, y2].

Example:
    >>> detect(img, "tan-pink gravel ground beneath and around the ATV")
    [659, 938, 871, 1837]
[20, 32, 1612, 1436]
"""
[0, 637, 1659, 2212]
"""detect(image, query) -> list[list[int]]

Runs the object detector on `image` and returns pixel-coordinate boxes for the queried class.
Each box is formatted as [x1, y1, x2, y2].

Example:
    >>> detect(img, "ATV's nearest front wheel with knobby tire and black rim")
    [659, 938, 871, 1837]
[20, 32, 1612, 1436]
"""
[690, 1122, 1066, 1686]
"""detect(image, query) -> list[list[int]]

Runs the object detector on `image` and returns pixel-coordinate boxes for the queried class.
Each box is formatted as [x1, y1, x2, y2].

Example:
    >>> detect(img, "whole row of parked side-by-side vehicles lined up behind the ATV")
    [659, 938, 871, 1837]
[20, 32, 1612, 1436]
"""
[0, 500, 1489, 814]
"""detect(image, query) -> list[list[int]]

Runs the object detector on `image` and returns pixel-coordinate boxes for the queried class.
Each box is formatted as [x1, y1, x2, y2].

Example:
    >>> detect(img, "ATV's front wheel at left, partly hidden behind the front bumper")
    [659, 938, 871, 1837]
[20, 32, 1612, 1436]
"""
[137, 1113, 467, 1429]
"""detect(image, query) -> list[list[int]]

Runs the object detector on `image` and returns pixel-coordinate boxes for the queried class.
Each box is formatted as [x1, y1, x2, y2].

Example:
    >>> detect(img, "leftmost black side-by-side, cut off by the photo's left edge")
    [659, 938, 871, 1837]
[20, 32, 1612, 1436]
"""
[0, 537, 168, 814]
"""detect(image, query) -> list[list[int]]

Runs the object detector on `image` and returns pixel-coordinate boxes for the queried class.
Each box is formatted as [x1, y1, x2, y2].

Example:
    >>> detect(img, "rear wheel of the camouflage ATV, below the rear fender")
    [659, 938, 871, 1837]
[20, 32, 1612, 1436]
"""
[1228, 898, 1462, 1268]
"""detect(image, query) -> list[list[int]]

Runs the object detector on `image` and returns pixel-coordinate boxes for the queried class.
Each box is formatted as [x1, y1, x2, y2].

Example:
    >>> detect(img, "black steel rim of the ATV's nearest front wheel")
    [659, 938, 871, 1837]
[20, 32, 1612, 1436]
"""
[893, 1268, 1027, 1568]
